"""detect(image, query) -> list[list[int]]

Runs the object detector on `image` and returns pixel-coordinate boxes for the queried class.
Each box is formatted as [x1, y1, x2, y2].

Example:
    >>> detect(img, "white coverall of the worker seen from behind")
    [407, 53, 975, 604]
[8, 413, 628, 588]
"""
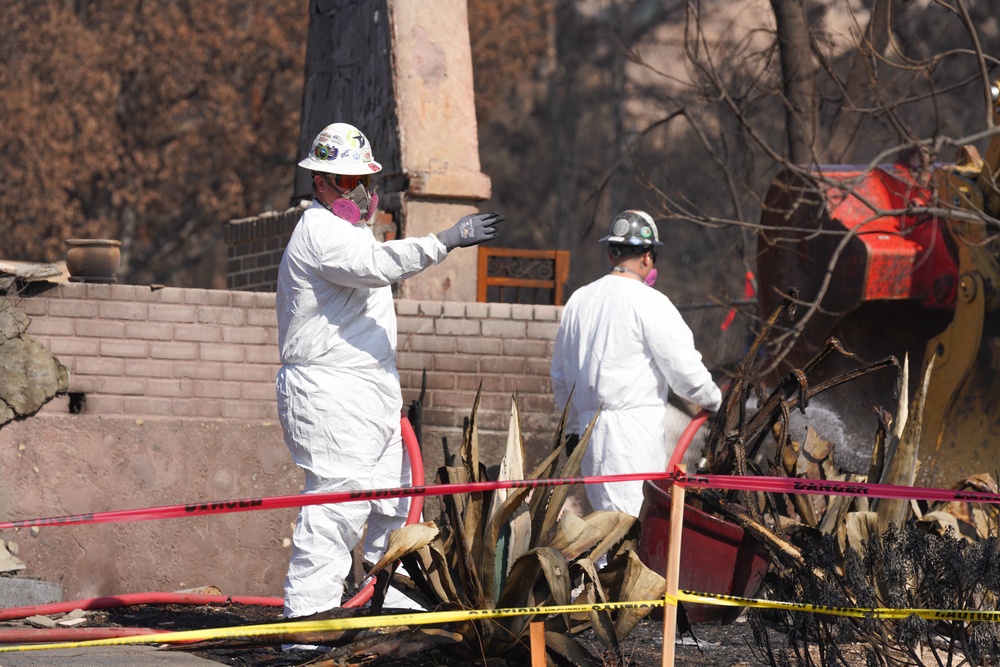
[551, 274, 722, 516]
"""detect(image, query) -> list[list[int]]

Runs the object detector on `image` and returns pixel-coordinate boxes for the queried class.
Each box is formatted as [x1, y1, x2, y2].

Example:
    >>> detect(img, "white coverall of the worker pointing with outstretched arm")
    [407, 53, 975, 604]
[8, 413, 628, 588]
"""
[275, 201, 448, 617]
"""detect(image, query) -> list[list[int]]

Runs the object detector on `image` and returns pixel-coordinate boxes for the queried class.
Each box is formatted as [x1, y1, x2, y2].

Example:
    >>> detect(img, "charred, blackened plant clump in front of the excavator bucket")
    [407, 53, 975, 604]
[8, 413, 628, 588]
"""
[688, 301, 1000, 667]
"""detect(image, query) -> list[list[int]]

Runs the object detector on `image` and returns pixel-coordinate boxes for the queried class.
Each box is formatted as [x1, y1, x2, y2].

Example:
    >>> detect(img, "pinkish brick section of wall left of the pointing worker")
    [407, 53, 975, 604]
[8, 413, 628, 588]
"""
[16, 283, 286, 419]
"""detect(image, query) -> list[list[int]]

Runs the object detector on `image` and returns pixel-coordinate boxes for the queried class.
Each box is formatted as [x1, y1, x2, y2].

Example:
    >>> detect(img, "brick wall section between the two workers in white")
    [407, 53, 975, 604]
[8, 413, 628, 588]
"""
[396, 300, 562, 477]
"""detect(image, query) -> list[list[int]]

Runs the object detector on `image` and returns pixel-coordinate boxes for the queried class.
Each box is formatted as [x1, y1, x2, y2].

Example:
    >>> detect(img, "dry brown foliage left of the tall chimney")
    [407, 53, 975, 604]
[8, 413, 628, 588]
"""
[0, 0, 308, 287]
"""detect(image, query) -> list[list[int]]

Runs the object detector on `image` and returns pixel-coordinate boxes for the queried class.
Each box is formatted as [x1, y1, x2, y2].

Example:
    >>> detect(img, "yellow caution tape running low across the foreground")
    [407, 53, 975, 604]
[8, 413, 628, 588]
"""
[7, 591, 1000, 653]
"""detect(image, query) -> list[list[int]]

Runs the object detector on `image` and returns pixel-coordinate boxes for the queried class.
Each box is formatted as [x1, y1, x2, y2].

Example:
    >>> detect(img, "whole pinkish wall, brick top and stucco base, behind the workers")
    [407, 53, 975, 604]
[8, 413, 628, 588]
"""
[0, 283, 559, 598]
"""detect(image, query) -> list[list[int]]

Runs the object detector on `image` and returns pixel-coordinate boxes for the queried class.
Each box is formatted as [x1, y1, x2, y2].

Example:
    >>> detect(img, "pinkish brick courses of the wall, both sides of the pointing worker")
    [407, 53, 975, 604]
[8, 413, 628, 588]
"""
[17, 283, 560, 470]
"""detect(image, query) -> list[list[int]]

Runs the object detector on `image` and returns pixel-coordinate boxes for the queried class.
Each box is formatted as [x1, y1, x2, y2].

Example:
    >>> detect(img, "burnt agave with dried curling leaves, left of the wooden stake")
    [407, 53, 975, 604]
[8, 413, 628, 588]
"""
[332, 396, 665, 666]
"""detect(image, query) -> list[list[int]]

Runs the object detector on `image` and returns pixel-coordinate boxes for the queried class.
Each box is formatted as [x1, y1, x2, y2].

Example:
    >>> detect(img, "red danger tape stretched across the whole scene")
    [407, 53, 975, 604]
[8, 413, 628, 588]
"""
[0, 472, 1000, 530]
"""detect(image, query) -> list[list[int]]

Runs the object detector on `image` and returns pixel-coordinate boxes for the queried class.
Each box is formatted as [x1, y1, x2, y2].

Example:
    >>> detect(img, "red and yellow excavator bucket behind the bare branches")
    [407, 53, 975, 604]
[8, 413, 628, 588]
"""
[757, 158, 1000, 487]
